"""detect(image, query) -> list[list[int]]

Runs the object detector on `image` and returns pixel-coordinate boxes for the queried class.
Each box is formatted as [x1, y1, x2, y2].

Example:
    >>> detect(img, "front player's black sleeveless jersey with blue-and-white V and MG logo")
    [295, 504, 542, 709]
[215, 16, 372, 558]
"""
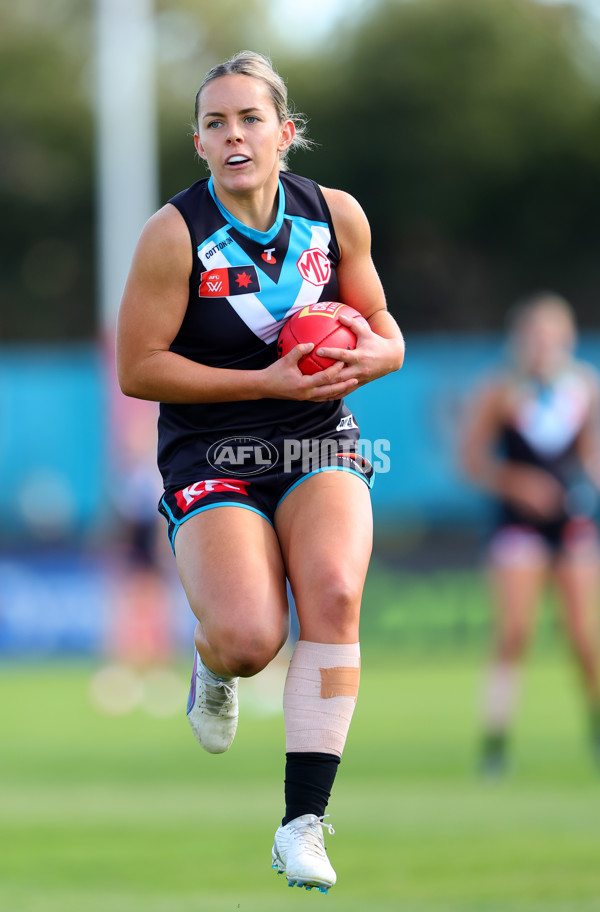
[158, 172, 349, 487]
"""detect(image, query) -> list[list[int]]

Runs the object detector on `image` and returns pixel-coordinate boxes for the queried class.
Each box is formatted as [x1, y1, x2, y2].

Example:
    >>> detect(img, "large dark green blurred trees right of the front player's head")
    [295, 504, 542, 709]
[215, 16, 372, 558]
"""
[288, 0, 600, 329]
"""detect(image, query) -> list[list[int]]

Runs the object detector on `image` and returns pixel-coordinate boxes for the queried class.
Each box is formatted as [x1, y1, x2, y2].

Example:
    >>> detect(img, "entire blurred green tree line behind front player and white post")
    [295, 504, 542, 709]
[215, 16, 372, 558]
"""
[0, 0, 600, 340]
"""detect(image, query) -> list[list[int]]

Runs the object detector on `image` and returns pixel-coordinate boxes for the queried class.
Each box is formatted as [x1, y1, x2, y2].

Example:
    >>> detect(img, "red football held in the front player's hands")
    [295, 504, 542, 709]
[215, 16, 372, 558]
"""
[277, 301, 369, 374]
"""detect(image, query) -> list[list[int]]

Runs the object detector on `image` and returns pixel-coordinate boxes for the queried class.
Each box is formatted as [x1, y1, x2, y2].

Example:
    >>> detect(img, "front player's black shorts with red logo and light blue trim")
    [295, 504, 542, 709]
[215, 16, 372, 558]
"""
[158, 415, 373, 551]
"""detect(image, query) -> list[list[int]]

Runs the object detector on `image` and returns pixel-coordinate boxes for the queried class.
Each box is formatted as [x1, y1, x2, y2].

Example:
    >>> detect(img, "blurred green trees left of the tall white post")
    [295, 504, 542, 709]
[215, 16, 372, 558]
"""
[0, 0, 95, 340]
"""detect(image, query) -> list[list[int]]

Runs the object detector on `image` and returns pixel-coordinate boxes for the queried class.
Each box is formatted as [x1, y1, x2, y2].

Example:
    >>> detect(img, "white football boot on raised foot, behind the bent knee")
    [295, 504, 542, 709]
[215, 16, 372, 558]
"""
[187, 650, 239, 754]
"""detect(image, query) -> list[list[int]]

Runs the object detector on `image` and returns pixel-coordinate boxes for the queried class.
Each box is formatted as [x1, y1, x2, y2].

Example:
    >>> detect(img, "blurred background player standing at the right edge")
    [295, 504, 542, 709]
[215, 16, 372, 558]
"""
[463, 293, 600, 773]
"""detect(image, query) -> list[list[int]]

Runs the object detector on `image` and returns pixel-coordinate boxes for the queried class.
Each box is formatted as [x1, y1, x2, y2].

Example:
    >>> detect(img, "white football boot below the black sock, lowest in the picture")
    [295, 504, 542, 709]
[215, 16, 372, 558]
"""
[271, 814, 337, 893]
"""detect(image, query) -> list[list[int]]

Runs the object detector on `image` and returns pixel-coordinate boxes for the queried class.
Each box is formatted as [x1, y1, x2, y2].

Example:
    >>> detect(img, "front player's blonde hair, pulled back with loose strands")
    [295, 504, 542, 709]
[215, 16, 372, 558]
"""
[194, 51, 314, 171]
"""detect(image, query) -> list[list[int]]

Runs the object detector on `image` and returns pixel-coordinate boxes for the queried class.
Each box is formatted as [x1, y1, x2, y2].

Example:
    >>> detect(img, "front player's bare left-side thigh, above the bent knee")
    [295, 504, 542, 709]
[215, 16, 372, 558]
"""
[175, 506, 288, 639]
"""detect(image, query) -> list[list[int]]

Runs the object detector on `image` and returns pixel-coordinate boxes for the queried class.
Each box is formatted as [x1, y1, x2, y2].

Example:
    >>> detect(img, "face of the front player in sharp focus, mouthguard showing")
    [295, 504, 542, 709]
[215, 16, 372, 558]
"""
[194, 74, 294, 193]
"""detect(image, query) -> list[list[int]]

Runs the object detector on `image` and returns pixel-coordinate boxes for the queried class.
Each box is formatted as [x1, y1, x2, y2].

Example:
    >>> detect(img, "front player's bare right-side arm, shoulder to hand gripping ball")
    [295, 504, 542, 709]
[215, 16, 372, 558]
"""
[321, 187, 404, 384]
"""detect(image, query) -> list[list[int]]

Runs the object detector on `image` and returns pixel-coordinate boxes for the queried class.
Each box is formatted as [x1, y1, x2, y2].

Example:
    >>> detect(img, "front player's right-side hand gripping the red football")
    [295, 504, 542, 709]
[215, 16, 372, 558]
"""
[317, 314, 398, 386]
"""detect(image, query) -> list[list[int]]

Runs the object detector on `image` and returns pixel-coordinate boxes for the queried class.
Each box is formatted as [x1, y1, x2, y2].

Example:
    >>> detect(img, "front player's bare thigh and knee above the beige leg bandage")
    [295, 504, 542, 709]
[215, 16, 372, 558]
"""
[275, 471, 373, 640]
